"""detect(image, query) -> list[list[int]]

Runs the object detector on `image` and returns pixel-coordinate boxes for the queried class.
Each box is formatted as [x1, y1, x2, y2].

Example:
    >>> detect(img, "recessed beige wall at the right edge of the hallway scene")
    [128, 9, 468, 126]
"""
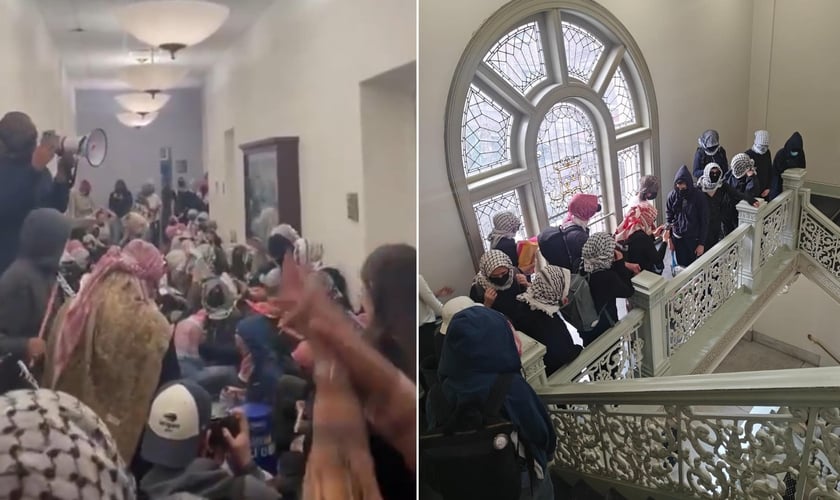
[361, 63, 417, 252]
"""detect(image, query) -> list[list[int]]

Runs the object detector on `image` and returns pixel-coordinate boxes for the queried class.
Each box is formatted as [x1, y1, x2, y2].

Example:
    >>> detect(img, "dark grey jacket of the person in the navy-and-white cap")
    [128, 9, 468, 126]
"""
[140, 458, 280, 500]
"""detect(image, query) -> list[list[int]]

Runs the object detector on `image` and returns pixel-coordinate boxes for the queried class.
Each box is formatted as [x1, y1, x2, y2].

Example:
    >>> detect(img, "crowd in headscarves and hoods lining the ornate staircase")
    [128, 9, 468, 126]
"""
[418, 130, 805, 500]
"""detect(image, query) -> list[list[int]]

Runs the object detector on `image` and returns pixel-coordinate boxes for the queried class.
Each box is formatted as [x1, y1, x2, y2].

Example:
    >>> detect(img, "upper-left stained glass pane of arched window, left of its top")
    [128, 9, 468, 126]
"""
[484, 23, 546, 95]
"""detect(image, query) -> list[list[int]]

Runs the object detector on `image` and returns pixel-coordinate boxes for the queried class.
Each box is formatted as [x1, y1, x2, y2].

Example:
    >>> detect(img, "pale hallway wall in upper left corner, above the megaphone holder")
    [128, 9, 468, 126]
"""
[0, 0, 75, 140]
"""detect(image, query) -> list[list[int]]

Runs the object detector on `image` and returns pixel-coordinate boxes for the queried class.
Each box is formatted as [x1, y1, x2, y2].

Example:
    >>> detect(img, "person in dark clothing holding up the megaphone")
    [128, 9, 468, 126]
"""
[0, 111, 75, 273]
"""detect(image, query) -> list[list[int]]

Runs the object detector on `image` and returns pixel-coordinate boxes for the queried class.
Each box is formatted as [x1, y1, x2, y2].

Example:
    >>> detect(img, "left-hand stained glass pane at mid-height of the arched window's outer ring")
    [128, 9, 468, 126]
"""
[461, 85, 511, 176]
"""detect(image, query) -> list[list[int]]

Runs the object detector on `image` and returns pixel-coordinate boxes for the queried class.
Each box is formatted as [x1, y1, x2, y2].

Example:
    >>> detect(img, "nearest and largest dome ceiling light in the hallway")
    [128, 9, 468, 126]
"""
[114, 0, 230, 59]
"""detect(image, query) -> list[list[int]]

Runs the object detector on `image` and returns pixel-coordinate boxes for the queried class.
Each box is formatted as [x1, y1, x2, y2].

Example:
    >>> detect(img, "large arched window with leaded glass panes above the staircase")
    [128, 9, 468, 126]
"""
[446, 0, 659, 261]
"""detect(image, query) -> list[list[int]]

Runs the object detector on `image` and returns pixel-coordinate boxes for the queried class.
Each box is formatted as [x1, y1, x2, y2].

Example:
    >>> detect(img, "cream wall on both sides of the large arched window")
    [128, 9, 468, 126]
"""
[419, 0, 753, 292]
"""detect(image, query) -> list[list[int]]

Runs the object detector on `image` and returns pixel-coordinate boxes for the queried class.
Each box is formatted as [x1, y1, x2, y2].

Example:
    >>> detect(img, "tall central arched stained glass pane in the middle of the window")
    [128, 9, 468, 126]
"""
[537, 102, 601, 224]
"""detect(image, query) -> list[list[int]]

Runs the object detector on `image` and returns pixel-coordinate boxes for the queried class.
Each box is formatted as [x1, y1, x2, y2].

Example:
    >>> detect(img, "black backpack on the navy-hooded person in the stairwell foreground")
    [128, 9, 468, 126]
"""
[420, 373, 523, 500]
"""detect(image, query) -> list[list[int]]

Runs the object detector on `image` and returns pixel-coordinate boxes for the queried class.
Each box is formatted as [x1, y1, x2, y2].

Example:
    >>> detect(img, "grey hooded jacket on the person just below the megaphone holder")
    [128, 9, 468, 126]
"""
[0, 208, 71, 348]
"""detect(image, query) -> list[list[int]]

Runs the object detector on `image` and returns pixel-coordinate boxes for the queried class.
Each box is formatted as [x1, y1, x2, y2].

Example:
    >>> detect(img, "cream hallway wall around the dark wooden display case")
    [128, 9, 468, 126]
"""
[204, 0, 416, 296]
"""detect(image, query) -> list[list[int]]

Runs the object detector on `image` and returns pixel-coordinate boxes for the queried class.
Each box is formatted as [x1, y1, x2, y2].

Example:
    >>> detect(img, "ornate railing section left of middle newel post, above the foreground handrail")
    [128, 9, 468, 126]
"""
[548, 309, 645, 385]
